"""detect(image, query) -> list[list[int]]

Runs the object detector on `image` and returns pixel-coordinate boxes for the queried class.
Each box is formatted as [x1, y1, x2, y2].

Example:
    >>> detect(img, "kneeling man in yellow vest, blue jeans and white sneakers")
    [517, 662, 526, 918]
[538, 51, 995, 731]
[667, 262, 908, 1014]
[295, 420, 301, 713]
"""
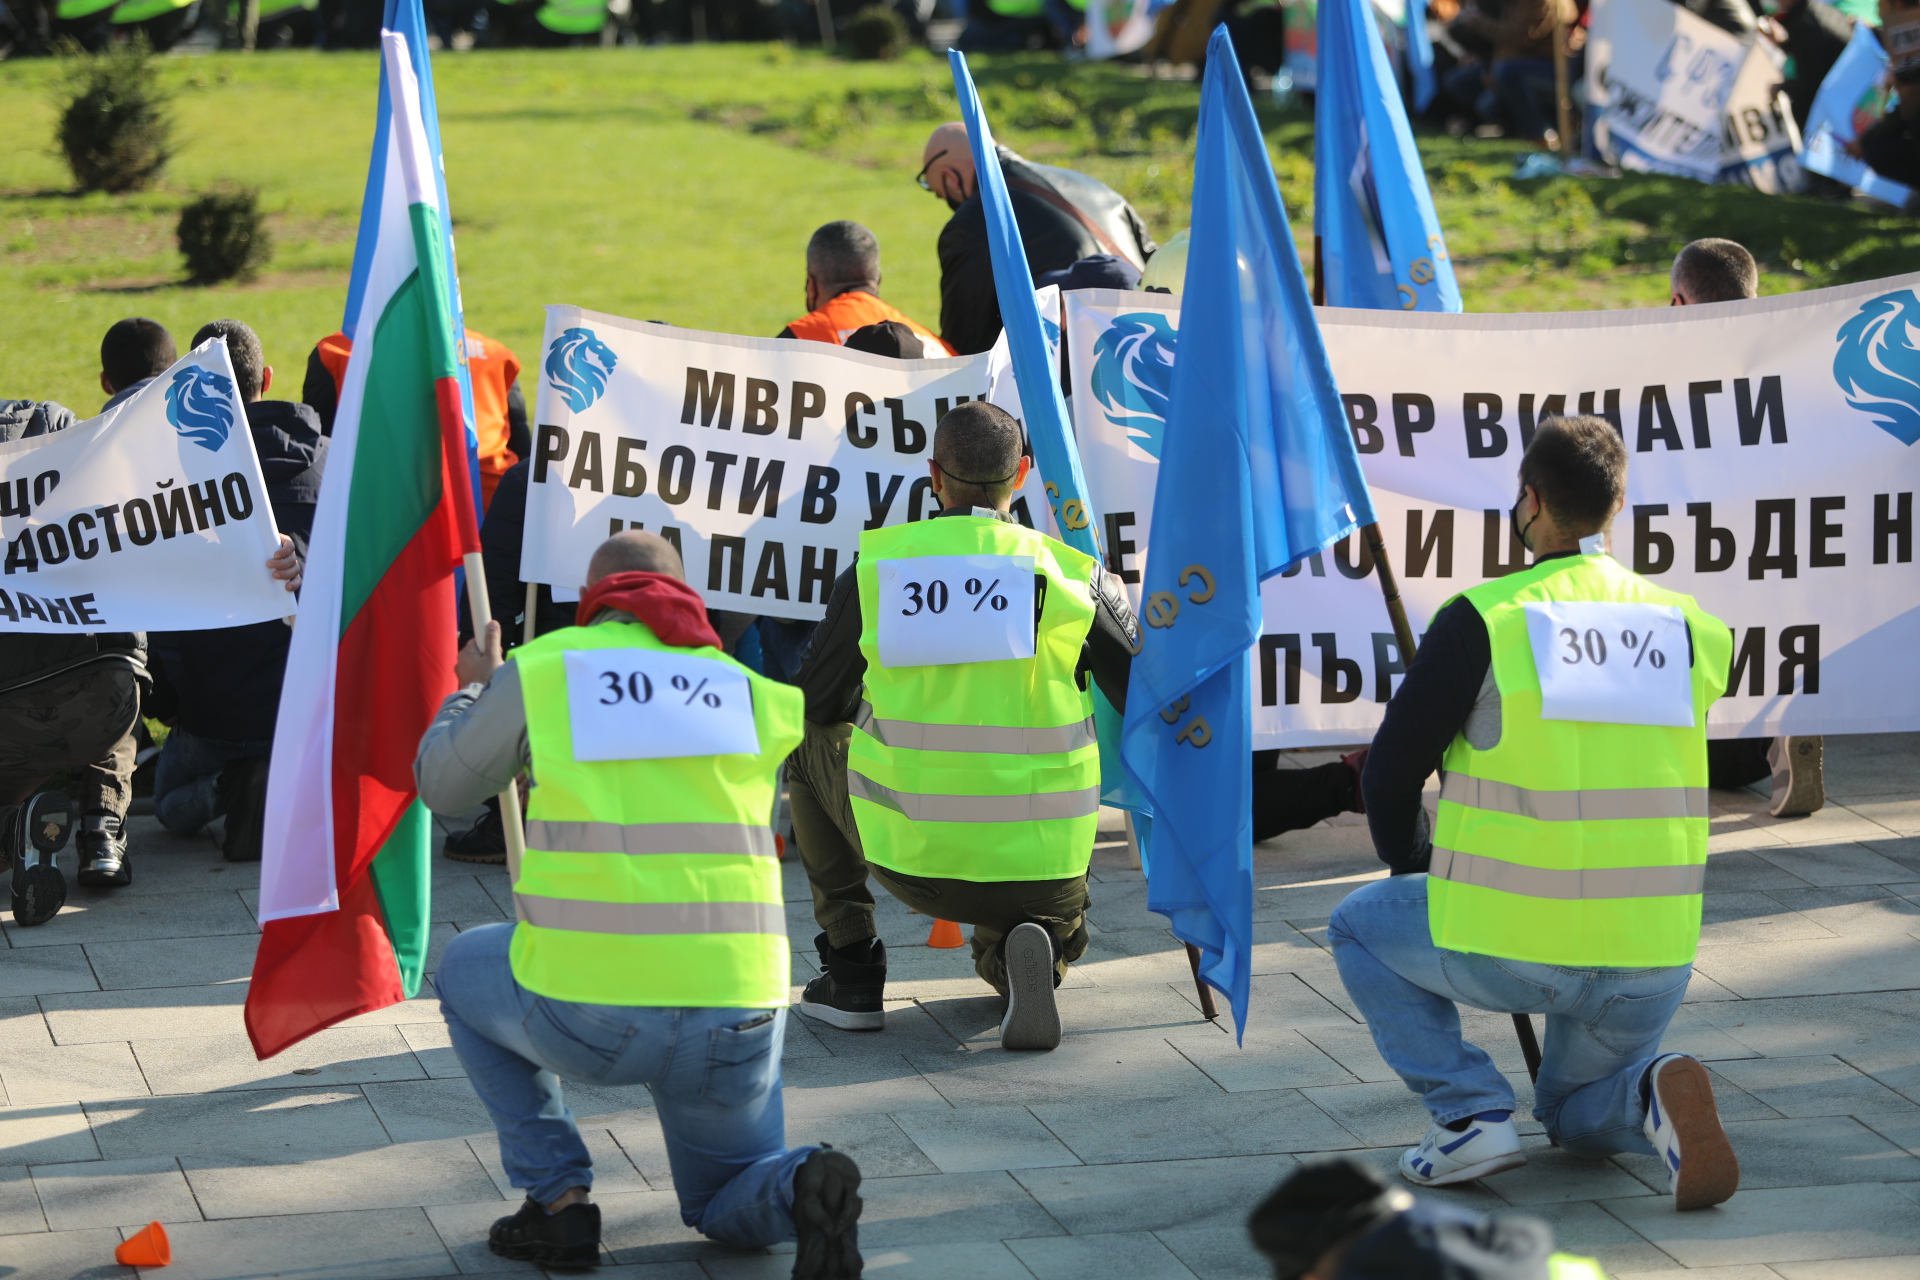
[1327, 416, 1740, 1209]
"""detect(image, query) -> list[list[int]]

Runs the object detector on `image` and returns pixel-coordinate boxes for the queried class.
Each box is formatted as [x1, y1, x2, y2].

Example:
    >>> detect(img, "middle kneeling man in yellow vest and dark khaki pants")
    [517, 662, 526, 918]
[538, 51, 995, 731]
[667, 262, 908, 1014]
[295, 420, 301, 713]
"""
[787, 401, 1140, 1050]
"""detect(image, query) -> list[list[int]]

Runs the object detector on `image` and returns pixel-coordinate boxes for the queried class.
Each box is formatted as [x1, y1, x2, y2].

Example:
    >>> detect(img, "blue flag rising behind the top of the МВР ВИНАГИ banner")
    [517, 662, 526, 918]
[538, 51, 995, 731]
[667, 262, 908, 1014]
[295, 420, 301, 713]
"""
[1313, 0, 1461, 311]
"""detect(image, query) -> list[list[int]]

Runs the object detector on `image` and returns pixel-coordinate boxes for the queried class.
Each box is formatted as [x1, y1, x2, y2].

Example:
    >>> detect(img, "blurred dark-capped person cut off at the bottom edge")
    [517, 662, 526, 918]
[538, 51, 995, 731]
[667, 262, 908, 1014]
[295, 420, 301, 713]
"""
[1246, 1159, 1605, 1280]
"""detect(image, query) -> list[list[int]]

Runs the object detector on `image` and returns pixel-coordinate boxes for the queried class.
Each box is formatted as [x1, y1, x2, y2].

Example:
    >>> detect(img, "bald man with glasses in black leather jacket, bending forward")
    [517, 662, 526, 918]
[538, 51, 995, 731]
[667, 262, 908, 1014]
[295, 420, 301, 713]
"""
[918, 123, 1160, 355]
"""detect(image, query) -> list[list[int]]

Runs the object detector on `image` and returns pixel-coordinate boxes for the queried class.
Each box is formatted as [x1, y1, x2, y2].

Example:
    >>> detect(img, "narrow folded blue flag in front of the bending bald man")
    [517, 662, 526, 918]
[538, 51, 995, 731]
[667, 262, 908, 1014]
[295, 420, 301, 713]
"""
[947, 50, 1100, 557]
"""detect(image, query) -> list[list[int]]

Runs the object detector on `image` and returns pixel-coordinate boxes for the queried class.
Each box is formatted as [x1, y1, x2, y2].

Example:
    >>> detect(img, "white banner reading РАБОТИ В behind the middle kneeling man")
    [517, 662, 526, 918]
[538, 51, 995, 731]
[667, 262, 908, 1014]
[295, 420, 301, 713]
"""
[520, 307, 1050, 620]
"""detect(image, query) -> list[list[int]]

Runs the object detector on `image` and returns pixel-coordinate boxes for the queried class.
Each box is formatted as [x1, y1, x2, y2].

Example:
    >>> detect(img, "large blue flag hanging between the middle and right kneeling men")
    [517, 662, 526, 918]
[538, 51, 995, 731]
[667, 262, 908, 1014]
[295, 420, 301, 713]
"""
[1121, 29, 1373, 1032]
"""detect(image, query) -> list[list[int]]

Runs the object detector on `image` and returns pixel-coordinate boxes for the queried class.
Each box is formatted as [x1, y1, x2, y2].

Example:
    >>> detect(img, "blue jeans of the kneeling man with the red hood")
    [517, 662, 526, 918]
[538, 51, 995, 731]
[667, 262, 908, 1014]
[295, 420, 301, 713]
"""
[434, 925, 818, 1249]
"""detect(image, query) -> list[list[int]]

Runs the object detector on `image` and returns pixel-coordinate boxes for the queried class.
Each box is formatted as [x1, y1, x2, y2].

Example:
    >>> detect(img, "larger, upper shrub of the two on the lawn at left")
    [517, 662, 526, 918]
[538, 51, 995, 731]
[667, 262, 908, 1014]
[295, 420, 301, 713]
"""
[56, 35, 173, 192]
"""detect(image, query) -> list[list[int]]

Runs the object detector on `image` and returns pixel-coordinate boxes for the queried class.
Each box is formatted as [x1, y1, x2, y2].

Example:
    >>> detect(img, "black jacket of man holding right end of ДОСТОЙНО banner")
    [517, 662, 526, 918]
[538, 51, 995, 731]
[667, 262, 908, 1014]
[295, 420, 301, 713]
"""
[148, 399, 328, 743]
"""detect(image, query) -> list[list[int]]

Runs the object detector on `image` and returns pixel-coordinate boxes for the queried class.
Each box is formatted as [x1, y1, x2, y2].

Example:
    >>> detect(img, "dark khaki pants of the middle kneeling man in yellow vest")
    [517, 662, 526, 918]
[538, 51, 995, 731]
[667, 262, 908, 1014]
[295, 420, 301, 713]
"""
[787, 722, 1087, 996]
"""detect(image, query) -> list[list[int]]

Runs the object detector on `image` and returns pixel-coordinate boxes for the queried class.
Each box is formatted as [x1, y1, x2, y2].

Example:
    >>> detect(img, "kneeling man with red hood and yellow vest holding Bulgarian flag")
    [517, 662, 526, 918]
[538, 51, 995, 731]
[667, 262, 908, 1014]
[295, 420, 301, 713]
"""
[415, 532, 875, 1280]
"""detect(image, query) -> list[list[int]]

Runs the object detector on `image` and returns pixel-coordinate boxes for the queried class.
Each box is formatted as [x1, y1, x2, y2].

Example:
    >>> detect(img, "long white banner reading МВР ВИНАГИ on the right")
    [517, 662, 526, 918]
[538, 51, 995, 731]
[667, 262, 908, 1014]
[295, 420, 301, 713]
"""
[1066, 274, 1920, 747]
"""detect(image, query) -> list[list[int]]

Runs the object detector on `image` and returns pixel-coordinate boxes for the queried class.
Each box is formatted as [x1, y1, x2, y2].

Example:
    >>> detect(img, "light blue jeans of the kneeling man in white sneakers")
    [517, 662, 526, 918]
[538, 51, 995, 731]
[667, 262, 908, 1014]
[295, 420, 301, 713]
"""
[1327, 875, 1693, 1157]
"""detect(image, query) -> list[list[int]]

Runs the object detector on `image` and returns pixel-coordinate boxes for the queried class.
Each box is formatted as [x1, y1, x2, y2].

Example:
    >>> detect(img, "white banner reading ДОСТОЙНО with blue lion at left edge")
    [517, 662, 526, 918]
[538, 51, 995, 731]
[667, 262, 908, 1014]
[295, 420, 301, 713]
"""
[0, 340, 294, 633]
